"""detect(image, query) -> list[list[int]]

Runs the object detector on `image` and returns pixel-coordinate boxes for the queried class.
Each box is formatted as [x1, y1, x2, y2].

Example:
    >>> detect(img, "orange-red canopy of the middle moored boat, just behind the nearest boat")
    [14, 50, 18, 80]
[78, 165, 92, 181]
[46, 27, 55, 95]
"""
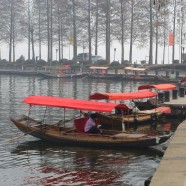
[89, 90, 157, 100]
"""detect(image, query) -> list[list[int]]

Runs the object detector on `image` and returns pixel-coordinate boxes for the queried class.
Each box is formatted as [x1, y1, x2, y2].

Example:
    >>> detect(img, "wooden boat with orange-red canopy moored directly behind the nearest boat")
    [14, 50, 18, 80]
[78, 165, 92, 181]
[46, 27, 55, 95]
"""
[89, 90, 171, 128]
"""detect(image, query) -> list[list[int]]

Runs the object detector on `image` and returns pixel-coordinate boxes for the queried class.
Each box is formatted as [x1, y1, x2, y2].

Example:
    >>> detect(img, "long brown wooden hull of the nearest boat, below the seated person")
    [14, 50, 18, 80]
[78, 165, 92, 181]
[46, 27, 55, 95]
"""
[10, 118, 171, 148]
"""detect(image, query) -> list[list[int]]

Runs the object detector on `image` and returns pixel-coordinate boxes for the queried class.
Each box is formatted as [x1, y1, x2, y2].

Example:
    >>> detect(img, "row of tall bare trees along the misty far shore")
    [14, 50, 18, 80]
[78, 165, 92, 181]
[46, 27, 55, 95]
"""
[0, 0, 183, 64]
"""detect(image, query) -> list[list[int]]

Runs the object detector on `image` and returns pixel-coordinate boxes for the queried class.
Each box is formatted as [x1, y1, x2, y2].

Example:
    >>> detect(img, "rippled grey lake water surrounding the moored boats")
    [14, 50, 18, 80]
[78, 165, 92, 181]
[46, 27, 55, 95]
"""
[0, 75, 183, 186]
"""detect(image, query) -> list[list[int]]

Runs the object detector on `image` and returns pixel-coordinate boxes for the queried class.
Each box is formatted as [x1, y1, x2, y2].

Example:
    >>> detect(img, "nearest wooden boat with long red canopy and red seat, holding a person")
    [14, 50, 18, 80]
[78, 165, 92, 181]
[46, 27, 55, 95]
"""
[10, 96, 171, 148]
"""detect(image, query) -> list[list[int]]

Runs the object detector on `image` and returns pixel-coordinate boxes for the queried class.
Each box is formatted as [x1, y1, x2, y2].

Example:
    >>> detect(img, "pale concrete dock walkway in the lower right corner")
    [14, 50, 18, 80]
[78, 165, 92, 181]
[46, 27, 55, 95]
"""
[150, 120, 186, 186]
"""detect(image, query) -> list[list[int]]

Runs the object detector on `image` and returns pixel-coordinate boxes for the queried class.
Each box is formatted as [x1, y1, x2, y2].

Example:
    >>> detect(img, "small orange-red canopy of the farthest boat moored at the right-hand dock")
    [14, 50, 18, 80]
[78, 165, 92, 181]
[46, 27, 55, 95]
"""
[138, 84, 176, 90]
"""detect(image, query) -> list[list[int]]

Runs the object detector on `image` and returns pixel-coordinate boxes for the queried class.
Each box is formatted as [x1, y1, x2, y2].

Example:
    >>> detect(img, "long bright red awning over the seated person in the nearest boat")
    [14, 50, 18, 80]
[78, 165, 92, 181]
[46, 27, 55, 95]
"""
[23, 96, 126, 112]
